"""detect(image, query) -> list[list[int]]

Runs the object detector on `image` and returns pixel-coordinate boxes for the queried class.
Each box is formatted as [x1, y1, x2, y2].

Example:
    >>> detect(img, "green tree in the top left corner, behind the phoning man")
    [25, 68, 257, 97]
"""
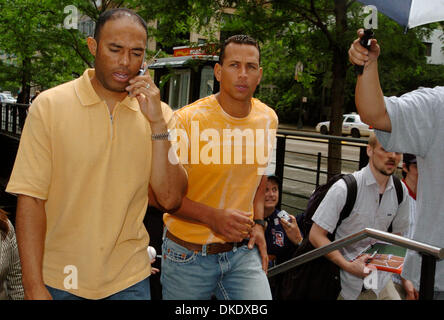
[0, 0, 90, 103]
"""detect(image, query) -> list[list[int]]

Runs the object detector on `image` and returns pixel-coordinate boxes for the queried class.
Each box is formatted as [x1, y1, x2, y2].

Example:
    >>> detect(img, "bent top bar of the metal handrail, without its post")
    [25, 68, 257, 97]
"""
[267, 228, 444, 278]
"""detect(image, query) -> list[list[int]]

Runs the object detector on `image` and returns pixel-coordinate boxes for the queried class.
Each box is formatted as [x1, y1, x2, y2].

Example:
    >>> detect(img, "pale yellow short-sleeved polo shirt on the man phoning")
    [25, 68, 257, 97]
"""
[6, 69, 174, 299]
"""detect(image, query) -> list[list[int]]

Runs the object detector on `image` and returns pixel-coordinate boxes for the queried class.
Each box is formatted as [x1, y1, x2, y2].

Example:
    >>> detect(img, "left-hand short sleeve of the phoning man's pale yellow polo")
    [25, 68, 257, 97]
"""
[6, 98, 52, 200]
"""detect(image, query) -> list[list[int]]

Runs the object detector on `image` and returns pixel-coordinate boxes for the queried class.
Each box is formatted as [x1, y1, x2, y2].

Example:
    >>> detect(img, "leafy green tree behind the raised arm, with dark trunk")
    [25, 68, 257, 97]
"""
[212, 0, 442, 176]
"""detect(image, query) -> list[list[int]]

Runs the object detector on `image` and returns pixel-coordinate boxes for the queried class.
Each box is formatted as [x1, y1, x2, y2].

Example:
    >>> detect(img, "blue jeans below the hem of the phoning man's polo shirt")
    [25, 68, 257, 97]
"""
[46, 278, 151, 300]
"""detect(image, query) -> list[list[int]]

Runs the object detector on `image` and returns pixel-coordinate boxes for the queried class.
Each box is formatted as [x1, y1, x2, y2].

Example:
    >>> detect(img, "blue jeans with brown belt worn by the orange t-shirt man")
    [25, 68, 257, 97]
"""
[160, 237, 271, 300]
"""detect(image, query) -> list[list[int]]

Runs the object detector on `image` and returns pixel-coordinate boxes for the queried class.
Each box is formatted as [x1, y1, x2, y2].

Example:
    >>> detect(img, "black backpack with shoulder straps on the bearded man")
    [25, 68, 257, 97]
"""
[275, 174, 403, 300]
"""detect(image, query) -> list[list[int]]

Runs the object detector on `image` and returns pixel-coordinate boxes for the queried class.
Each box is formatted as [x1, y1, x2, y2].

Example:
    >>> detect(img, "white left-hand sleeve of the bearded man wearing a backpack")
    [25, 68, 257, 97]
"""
[312, 179, 347, 233]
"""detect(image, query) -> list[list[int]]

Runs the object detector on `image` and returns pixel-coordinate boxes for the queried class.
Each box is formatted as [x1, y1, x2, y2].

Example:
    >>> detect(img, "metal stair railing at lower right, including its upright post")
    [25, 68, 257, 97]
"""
[268, 228, 444, 300]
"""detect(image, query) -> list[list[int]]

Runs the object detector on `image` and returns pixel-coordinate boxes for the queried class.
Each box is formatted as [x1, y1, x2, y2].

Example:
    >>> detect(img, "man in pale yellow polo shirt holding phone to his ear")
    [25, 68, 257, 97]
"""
[7, 9, 187, 299]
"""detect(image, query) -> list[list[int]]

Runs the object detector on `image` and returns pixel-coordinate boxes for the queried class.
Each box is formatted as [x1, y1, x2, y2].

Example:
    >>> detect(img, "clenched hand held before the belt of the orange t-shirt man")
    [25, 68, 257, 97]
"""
[209, 209, 254, 242]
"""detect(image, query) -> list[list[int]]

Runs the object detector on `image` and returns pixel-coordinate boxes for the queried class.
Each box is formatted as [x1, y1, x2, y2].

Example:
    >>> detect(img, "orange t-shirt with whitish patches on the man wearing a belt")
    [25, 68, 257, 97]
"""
[164, 95, 278, 244]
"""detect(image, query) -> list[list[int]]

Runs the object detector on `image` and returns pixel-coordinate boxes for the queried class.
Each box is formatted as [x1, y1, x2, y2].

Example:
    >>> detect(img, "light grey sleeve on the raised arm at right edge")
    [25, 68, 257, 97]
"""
[375, 87, 444, 157]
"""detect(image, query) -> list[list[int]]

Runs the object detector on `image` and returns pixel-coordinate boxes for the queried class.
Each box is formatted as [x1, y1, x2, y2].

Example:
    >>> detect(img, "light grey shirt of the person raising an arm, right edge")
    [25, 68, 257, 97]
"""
[376, 87, 444, 291]
